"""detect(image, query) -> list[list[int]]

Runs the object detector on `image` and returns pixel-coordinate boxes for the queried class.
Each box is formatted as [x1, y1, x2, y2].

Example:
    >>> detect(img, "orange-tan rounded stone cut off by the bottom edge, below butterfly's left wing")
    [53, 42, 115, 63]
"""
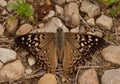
[38, 73, 57, 84]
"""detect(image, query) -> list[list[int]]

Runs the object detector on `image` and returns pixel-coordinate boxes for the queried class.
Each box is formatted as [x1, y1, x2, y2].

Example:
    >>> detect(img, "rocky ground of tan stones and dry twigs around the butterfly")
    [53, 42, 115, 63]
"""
[0, 0, 120, 84]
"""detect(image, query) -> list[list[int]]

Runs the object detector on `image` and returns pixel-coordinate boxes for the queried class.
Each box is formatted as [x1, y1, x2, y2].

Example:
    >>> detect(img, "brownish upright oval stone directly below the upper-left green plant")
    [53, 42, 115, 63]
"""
[6, 17, 18, 34]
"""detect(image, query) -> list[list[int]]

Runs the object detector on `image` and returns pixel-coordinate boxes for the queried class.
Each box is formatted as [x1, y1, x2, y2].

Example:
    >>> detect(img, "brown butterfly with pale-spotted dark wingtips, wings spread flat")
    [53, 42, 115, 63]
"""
[15, 28, 105, 74]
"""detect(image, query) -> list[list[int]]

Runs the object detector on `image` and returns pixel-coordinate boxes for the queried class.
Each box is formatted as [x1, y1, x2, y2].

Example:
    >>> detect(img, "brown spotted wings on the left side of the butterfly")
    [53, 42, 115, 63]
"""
[15, 33, 57, 72]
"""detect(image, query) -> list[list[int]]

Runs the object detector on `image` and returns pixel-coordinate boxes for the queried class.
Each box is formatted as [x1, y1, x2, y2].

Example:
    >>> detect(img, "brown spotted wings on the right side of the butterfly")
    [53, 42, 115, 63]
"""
[63, 33, 105, 73]
